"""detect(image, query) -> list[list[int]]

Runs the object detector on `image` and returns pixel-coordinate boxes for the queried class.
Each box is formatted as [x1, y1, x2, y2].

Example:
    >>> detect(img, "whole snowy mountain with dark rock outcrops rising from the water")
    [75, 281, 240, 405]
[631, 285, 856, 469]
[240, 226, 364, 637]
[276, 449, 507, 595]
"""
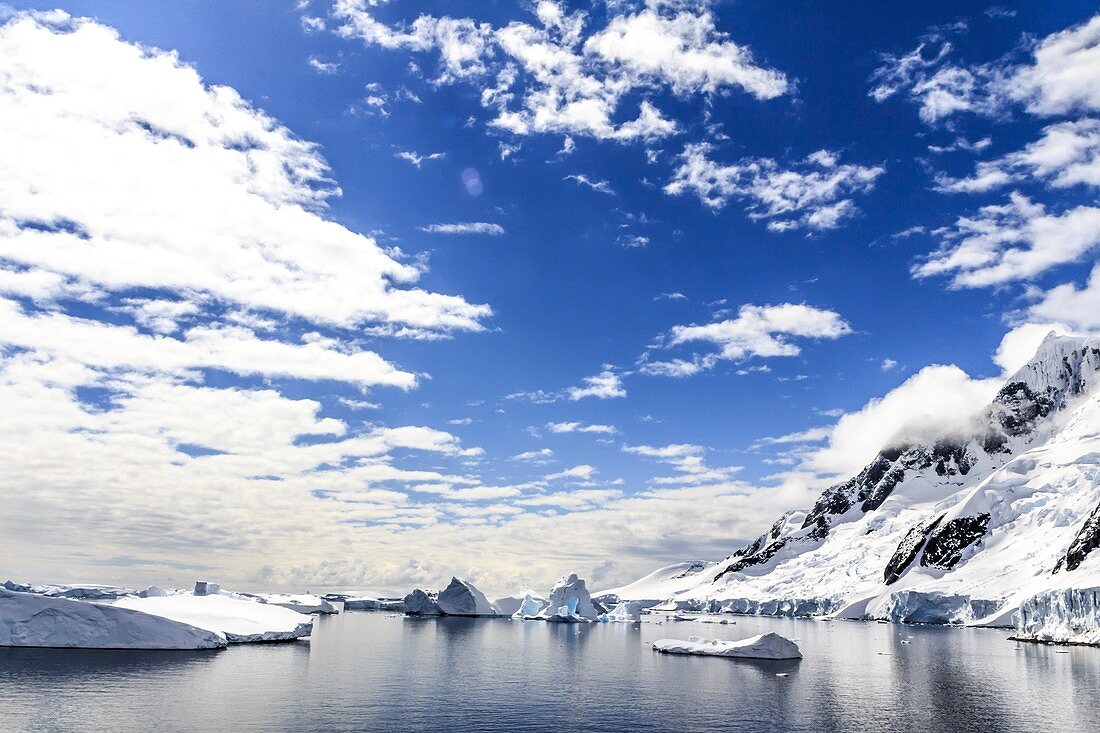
[607, 333, 1100, 638]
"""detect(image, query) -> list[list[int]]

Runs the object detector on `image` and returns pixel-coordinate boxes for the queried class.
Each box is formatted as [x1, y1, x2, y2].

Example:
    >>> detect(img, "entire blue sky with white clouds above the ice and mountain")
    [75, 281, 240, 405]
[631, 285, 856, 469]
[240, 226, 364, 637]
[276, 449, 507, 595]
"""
[0, 0, 1100, 592]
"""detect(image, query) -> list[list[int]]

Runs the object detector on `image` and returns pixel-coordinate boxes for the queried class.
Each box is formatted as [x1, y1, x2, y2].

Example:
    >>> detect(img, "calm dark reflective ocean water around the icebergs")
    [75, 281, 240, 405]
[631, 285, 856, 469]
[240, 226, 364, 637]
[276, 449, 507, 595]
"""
[0, 613, 1100, 733]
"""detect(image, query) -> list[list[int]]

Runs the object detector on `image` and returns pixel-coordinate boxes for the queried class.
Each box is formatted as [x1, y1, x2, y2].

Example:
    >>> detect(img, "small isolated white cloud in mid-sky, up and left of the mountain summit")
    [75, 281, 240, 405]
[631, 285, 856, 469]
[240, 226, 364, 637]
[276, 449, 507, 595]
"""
[655, 303, 851, 373]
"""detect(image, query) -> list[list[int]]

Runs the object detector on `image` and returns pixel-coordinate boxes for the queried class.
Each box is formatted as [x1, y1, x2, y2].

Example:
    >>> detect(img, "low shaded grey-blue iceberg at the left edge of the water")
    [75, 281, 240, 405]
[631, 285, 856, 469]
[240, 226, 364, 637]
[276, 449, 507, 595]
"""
[0, 589, 227, 649]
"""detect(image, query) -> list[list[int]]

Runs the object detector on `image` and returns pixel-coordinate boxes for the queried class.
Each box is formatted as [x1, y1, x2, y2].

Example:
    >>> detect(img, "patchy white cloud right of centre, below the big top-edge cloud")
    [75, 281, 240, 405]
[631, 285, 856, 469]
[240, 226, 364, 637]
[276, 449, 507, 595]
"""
[664, 143, 886, 231]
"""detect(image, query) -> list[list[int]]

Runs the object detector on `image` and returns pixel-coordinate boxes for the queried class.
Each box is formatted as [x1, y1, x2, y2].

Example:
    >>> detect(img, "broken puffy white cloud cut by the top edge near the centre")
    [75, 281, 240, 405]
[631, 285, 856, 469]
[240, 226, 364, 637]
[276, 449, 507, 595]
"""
[331, 0, 789, 142]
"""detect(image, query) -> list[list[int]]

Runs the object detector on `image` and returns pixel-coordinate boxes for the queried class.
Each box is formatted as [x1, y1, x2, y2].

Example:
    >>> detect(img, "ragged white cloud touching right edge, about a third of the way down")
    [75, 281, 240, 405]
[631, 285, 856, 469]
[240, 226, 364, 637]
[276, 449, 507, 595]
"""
[913, 193, 1100, 287]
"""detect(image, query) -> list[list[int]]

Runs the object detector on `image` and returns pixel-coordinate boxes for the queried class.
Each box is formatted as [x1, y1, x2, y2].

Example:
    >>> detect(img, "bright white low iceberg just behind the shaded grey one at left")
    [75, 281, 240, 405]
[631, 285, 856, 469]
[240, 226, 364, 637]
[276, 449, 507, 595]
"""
[114, 593, 314, 644]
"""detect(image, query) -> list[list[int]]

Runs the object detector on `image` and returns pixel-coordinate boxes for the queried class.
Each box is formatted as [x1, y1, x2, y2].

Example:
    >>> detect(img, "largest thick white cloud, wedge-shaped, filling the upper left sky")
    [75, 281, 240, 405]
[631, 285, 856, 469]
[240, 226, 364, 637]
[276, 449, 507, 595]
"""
[0, 13, 491, 331]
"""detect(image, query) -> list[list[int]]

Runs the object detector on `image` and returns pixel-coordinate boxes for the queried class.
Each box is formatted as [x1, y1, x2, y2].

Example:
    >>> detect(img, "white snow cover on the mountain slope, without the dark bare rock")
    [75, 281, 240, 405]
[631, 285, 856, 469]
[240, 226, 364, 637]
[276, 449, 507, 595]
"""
[600, 336, 1100, 643]
